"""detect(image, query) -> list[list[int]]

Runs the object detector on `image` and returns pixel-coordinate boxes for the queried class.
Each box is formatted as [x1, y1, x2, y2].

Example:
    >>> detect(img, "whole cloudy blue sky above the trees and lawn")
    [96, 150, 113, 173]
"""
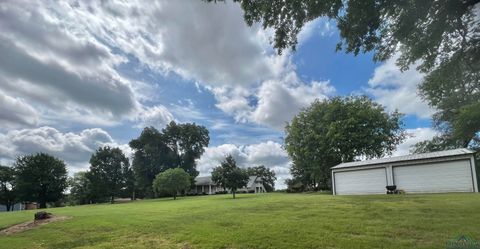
[0, 0, 436, 188]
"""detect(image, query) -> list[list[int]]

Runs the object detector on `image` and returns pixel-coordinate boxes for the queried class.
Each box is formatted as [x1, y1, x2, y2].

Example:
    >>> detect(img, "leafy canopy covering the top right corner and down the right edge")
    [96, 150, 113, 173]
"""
[222, 0, 480, 152]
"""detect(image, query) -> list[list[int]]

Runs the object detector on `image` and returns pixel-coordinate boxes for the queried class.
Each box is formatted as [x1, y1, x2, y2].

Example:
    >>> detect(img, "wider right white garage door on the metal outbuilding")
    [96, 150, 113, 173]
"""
[393, 160, 473, 193]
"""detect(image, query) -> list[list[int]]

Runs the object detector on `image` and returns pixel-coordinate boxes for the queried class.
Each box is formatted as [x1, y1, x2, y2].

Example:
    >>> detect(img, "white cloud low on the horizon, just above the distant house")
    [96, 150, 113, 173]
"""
[197, 141, 291, 188]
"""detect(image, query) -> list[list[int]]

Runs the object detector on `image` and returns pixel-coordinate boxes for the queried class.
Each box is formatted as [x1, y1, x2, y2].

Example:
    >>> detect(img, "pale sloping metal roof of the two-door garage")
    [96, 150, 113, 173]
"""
[331, 148, 475, 169]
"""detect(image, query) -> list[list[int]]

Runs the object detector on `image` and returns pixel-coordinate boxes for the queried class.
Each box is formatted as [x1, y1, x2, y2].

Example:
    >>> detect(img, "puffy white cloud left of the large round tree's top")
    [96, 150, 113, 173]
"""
[212, 71, 335, 130]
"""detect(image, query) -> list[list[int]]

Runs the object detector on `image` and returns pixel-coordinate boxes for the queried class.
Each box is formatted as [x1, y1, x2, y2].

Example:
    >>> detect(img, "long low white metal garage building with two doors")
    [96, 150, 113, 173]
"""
[331, 149, 478, 195]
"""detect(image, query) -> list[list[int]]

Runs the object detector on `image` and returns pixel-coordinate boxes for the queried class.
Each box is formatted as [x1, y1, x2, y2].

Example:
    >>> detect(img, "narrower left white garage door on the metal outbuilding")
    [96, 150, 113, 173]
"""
[334, 168, 387, 195]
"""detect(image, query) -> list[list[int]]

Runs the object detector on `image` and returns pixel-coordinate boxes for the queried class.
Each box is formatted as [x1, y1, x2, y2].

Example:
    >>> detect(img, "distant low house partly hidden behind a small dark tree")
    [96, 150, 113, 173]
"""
[192, 176, 267, 195]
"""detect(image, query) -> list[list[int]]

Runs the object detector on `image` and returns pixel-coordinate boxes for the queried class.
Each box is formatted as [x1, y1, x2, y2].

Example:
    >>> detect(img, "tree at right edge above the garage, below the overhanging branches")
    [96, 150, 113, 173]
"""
[419, 59, 480, 147]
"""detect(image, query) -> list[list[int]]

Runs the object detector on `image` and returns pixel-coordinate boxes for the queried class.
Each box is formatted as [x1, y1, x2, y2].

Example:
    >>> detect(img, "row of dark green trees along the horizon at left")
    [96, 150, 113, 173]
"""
[0, 121, 276, 211]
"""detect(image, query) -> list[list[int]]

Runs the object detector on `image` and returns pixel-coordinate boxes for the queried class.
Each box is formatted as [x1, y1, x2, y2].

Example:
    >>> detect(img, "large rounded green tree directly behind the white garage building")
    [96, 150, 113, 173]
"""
[285, 96, 405, 190]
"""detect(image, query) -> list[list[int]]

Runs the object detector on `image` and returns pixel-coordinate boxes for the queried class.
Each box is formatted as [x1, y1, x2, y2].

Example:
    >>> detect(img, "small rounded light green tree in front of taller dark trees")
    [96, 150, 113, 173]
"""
[153, 168, 191, 200]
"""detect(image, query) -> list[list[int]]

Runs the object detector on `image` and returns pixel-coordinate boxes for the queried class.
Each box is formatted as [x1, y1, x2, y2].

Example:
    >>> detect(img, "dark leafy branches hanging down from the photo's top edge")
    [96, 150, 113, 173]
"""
[227, 0, 480, 72]
